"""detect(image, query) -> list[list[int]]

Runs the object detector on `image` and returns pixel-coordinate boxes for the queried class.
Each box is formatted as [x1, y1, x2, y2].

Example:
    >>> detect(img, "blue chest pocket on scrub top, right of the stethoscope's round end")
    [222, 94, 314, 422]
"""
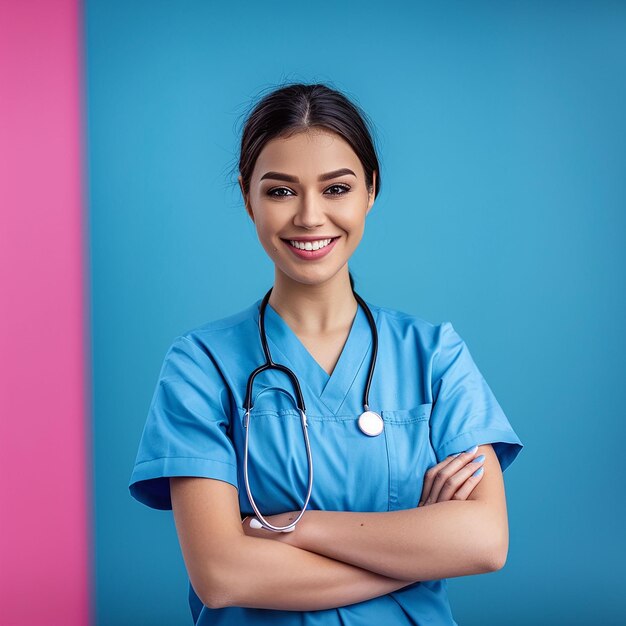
[382, 403, 437, 511]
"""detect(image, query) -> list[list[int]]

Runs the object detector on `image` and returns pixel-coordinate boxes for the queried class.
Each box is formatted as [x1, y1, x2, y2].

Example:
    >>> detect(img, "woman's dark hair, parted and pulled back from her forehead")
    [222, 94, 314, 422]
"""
[239, 83, 381, 289]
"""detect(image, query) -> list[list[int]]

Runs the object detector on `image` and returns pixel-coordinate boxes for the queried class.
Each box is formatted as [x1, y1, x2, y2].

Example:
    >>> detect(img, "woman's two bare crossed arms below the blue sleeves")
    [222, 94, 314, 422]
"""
[170, 444, 508, 611]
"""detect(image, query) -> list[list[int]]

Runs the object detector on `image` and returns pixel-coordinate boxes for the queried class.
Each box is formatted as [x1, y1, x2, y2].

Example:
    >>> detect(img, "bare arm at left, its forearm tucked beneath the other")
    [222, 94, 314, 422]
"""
[170, 477, 410, 611]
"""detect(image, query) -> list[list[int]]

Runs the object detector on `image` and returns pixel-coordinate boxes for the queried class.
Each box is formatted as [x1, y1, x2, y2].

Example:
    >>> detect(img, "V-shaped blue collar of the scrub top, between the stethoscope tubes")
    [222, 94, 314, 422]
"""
[255, 299, 378, 415]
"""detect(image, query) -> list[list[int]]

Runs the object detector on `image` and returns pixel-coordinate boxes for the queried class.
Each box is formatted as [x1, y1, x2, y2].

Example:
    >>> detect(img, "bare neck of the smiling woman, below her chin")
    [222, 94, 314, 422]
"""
[269, 264, 358, 335]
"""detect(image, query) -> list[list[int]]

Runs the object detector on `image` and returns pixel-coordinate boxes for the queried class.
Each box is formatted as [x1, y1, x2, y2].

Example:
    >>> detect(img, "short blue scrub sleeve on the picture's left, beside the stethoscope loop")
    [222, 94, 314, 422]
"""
[128, 336, 239, 510]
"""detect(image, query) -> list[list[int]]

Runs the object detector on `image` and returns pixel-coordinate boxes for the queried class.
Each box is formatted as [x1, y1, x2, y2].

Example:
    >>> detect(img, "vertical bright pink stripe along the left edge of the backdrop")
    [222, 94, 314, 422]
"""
[0, 0, 92, 626]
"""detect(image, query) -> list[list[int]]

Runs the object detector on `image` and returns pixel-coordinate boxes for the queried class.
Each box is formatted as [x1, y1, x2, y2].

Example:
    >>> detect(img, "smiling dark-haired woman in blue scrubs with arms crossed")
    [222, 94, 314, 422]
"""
[130, 84, 522, 626]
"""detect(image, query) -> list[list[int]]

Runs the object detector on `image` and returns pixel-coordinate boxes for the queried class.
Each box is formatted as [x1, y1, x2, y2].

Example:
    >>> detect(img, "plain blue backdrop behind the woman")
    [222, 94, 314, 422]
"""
[85, 0, 626, 626]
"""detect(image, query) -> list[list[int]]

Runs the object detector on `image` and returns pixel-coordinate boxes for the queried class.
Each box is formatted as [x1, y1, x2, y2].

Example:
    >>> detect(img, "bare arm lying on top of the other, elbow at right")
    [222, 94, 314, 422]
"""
[246, 445, 508, 581]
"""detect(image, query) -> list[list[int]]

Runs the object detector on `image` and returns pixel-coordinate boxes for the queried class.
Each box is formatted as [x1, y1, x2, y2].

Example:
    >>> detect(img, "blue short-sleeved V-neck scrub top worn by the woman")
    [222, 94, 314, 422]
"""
[129, 299, 523, 626]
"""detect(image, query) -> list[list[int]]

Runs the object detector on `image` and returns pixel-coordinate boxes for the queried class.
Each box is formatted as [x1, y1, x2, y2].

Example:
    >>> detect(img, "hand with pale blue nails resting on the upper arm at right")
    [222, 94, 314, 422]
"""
[417, 447, 485, 507]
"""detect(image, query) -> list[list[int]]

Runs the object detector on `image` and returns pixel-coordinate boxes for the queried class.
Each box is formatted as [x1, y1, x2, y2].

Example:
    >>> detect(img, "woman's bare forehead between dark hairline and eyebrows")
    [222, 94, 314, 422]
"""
[253, 128, 360, 178]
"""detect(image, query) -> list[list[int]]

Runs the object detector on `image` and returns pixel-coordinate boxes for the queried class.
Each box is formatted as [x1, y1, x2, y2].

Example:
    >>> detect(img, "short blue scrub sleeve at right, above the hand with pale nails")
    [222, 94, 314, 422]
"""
[430, 322, 523, 471]
